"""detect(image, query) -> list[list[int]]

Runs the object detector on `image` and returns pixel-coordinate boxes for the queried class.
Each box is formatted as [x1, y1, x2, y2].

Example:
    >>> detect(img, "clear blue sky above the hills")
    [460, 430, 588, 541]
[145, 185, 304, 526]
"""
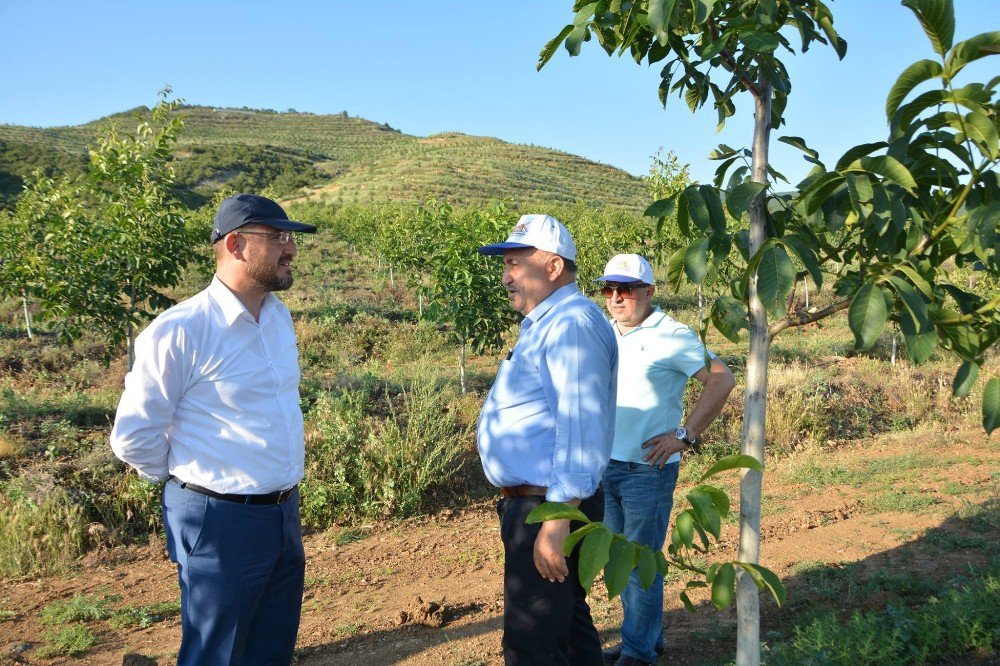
[0, 0, 1000, 183]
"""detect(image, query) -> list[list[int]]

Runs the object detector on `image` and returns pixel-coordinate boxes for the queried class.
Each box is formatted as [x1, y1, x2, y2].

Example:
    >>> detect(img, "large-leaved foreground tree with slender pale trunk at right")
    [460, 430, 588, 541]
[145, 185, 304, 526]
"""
[539, 0, 1000, 664]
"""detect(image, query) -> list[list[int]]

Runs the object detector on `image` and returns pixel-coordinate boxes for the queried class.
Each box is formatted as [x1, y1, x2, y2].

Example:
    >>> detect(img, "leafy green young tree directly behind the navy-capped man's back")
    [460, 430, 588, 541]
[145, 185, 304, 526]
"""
[88, 89, 193, 368]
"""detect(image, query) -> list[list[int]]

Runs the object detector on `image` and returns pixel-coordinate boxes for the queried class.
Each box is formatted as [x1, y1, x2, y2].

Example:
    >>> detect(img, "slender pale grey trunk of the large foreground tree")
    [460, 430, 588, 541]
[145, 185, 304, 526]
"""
[736, 82, 771, 666]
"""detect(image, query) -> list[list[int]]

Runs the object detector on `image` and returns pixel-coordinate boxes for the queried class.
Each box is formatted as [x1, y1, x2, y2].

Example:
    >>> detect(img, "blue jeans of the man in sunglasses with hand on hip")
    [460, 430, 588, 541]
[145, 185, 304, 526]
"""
[603, 460, 680, 663]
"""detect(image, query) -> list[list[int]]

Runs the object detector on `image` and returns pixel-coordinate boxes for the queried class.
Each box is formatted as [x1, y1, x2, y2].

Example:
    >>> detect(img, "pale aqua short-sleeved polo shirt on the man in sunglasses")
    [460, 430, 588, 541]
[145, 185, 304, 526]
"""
[611, 308, 715, 463]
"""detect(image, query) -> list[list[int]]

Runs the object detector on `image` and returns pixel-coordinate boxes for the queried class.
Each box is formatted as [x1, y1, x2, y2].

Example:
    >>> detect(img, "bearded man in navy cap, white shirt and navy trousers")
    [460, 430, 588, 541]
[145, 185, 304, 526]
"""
[111, 194, 316, 665]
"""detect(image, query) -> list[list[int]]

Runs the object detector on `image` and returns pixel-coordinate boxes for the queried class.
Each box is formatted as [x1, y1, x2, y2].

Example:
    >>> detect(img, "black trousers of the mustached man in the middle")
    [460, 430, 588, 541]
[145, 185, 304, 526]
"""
[497, 490, 604, 666]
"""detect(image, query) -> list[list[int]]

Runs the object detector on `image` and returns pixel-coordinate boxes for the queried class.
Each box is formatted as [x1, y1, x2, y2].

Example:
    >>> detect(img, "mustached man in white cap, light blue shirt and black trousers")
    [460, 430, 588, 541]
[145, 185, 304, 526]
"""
[477, 215, 618, 666]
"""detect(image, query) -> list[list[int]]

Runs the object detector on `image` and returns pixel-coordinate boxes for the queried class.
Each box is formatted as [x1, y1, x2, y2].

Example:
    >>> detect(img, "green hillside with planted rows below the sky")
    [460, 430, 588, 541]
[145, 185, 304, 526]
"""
[0, 106, 648, 209]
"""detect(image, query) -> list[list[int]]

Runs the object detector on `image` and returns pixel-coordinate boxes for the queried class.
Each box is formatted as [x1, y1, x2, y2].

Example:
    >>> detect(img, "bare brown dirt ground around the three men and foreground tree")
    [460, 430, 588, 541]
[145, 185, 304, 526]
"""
[0, 433, 1000, 666]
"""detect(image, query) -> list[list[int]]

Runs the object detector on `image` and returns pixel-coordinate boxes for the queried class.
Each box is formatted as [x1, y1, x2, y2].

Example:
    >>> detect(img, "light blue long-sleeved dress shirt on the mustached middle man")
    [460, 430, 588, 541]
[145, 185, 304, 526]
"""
[477, 284, 618, 502]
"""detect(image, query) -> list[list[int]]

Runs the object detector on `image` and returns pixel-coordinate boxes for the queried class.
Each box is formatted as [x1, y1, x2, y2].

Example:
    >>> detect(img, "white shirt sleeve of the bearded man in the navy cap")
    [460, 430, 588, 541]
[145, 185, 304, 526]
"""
[111, 322, 190, 481]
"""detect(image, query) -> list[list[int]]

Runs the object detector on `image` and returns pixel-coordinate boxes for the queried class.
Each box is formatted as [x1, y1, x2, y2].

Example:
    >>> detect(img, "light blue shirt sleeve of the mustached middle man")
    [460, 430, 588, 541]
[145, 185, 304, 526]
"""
[540, 321, 618, 502]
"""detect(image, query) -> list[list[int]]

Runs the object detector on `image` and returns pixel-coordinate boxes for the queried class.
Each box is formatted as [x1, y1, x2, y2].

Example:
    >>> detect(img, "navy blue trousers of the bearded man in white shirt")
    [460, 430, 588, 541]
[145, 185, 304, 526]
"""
[163, 480, 305, 666]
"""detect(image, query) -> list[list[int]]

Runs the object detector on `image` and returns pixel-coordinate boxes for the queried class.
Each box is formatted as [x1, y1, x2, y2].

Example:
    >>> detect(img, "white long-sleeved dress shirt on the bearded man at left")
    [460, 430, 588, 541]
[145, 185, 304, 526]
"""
[111, 277, 304, 494]
